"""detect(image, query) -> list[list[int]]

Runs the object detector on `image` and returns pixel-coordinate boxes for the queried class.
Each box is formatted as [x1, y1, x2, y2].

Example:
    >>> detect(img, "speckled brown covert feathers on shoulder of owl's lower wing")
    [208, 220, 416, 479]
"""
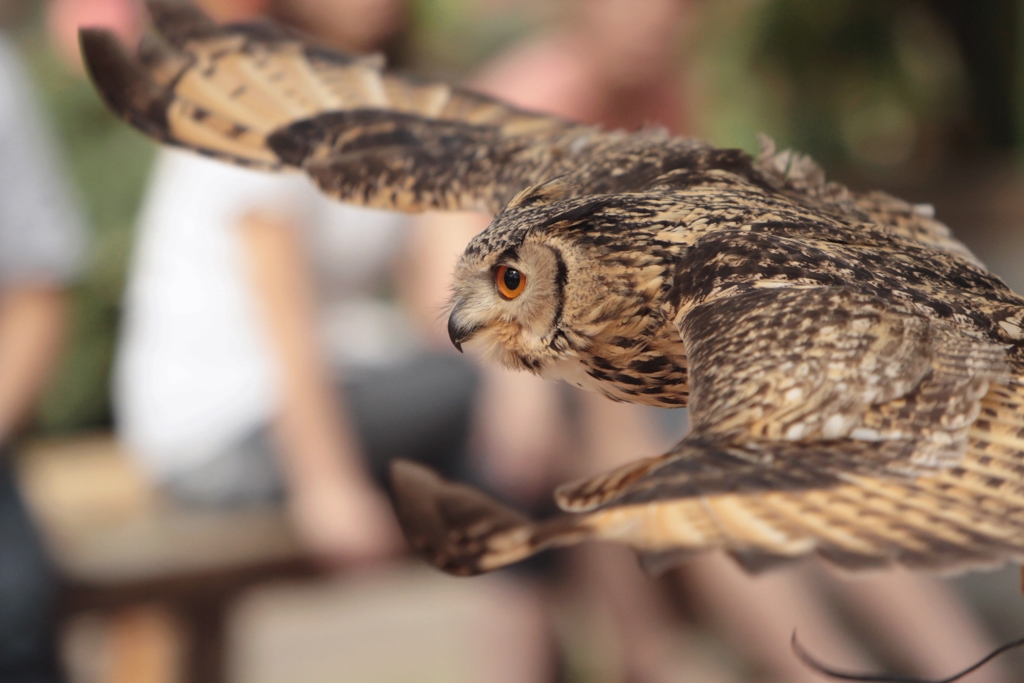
[679, 287, 1008, 462]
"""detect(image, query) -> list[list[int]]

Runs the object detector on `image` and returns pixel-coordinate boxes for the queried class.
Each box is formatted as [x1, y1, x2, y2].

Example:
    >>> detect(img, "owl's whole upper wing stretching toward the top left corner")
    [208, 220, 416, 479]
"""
[81, 1, 603, 212]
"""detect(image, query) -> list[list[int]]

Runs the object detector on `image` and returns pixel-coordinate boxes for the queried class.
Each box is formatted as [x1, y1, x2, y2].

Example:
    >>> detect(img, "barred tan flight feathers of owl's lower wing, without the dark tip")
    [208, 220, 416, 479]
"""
[584, 440, 1024, 570]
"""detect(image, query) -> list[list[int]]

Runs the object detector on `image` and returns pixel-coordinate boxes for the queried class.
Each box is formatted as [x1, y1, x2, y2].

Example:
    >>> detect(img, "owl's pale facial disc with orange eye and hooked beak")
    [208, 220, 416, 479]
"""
[447, 241, 565, 372]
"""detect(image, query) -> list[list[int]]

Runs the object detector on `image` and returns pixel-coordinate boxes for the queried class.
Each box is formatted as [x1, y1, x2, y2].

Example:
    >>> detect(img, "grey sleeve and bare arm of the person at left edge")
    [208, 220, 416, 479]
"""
[0, 36, 86, 442]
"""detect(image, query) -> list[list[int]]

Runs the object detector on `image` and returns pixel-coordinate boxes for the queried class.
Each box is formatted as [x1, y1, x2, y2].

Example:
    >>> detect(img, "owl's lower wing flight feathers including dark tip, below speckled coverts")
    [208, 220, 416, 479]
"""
[395, 385, 1024, 574]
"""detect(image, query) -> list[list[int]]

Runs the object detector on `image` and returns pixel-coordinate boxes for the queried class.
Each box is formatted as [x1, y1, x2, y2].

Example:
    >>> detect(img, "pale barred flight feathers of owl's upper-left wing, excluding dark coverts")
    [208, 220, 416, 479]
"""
[80, 0, 559, 176]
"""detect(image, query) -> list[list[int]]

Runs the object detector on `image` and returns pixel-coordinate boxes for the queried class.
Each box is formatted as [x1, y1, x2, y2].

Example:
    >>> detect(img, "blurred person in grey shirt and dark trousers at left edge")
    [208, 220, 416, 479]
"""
[0, 12, 85, 683]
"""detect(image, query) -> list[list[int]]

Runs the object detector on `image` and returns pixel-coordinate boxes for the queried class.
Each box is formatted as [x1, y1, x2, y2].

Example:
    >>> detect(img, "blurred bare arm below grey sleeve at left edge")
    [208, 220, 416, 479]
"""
[0, 285, 68, 442]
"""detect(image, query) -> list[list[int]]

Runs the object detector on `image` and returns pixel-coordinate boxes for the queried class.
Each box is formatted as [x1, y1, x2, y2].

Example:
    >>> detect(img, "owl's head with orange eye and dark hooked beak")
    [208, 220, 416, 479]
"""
[447, 186, 665, 374]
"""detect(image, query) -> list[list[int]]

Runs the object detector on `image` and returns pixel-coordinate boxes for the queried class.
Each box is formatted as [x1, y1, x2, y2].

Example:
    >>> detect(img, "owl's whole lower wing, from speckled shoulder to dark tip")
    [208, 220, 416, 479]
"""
[395, 288, 1024, 573]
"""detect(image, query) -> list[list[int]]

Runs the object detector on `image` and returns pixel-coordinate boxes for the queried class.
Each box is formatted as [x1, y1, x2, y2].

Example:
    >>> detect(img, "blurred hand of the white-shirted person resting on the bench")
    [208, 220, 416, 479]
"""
[289, 477, 403, 566]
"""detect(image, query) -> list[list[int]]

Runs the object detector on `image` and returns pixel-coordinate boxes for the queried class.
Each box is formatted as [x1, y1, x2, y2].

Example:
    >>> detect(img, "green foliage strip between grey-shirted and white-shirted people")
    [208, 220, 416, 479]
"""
[20, 30, 154, 432]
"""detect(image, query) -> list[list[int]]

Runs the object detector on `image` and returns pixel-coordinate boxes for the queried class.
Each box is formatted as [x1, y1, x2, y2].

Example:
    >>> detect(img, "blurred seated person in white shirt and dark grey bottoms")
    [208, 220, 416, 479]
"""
[115, 0, 448, 563]
